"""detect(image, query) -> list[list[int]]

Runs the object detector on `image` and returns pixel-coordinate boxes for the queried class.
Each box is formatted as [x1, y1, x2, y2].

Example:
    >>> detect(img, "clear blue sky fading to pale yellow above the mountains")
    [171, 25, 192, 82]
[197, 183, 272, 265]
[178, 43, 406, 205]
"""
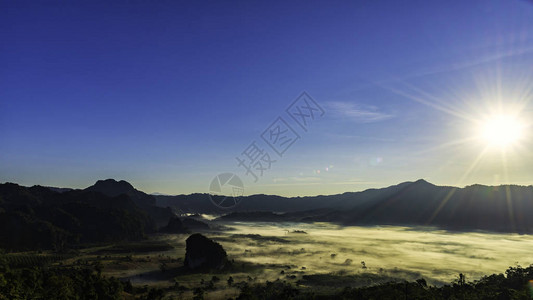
[0, 0, 533, 195]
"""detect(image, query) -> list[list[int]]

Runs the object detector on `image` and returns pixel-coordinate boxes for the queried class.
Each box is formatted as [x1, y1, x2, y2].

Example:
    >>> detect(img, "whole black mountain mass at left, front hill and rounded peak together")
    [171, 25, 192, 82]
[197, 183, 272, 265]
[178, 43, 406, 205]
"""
[0, 179, 197, 251]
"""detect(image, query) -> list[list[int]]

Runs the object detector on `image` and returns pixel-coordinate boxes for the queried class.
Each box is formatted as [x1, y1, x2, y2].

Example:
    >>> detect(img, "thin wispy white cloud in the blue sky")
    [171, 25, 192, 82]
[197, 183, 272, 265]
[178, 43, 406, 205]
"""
[326, 101, 393, 123]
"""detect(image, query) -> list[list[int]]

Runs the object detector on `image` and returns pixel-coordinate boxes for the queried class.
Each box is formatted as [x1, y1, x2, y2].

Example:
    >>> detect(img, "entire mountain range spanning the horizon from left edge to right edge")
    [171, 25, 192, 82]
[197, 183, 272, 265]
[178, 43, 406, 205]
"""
[0, 179, 533, 250]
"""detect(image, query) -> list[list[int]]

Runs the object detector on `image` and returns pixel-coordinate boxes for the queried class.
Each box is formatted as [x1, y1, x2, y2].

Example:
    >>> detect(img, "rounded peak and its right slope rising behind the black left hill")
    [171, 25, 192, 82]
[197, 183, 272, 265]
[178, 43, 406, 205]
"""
[85, 179, 174, 227]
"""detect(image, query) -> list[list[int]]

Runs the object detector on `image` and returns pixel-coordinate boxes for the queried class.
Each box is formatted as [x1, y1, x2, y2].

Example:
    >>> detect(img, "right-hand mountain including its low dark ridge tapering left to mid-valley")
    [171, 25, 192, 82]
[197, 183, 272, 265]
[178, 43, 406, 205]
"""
[206, 180, 533, 233]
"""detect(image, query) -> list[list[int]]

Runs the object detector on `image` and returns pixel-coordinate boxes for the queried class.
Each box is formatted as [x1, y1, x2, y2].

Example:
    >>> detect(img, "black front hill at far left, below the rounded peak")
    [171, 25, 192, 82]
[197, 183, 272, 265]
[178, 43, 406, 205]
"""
[0, 183, 155, 250]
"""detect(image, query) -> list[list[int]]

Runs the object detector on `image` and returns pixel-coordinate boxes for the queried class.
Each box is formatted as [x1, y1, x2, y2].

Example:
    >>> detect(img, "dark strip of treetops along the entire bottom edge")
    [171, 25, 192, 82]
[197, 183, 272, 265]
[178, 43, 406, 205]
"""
[0, 255, 533, 300]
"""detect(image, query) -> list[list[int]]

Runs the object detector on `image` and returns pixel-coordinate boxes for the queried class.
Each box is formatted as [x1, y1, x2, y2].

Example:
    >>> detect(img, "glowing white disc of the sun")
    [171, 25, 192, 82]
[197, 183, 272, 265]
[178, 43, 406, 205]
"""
[480, 114, 523, 148]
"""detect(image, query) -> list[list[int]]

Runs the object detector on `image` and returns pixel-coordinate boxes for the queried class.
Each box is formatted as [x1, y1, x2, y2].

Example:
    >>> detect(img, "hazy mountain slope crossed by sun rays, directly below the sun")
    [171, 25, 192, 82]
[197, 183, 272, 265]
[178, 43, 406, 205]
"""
[335, 181, 533, 233]
